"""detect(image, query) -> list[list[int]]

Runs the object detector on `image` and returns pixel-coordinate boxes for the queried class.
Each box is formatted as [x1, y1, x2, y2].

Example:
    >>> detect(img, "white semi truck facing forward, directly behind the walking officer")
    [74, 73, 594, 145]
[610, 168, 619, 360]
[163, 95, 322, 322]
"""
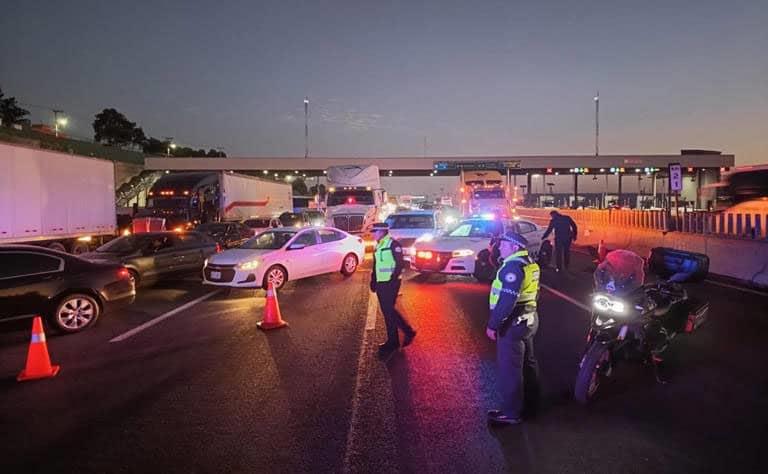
[325, 165, 387, 234]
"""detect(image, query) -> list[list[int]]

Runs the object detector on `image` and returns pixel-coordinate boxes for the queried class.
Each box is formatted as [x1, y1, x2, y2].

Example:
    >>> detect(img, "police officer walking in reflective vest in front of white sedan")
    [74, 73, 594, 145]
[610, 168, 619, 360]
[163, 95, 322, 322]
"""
[371, 222, 416, 356]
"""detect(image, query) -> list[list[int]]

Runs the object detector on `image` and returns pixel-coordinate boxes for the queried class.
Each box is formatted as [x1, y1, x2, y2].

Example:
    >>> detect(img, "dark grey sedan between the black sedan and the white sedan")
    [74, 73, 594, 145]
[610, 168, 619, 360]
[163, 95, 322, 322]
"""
[80, 232, 221, 286]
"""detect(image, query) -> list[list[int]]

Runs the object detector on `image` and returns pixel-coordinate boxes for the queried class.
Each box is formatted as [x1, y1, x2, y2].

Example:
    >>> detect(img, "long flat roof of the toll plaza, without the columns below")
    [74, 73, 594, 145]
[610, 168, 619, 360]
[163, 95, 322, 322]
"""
[145, 150, 734, 176]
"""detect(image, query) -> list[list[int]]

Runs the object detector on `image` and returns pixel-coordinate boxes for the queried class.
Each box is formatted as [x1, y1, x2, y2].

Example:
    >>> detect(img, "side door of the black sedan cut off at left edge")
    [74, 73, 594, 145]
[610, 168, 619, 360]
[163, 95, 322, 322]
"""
[0, 251, 65, 320]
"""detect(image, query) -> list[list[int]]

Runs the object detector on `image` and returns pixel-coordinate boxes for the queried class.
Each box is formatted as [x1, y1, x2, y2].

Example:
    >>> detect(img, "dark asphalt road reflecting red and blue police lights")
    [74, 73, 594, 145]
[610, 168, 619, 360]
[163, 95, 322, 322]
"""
[0, 250, 768, 473]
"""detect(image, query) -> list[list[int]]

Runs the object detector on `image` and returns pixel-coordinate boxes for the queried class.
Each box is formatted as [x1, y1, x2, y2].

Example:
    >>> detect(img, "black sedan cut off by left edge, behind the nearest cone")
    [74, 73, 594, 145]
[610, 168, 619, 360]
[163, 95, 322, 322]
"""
[0, 245, 136, 333]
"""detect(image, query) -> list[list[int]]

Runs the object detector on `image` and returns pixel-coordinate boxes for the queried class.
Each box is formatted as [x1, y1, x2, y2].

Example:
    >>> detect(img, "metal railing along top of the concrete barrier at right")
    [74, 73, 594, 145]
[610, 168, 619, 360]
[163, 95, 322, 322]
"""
[518, 208, 768, 240]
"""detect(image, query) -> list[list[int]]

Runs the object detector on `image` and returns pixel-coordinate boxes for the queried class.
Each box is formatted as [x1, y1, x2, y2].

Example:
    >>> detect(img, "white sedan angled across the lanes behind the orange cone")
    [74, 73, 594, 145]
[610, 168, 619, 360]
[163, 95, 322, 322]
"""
[203, 227, 365, 289]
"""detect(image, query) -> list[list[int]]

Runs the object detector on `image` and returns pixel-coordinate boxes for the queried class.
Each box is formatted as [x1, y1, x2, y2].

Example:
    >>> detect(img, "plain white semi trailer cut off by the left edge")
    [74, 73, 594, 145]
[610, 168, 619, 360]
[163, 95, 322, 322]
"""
[0, 143, 117, 254]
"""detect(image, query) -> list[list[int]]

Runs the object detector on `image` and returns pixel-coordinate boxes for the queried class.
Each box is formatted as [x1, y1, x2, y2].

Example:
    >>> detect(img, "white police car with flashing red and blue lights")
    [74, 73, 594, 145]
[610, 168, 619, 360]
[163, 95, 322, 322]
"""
[406, 218, 544, 275]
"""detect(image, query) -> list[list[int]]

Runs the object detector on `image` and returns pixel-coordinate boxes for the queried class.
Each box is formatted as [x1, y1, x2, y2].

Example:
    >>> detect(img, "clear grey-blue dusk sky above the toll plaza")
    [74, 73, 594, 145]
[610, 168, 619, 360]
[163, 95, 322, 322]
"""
[0, 0, 768, 164]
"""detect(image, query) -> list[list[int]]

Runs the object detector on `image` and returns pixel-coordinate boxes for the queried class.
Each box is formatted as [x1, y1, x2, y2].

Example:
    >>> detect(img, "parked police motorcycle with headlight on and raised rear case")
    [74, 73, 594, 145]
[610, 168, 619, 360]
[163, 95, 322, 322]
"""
[574, 247, 709, 404]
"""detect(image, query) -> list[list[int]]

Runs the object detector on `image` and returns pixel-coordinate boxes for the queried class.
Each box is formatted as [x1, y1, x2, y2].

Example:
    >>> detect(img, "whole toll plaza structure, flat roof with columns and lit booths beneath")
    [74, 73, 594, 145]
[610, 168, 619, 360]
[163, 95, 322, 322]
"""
[145, 150, 734, 208]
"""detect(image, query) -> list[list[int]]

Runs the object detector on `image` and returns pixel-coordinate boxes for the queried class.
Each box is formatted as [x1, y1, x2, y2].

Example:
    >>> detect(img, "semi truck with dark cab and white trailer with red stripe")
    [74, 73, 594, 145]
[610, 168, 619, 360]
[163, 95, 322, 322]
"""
[138, 171, 293, 230]
